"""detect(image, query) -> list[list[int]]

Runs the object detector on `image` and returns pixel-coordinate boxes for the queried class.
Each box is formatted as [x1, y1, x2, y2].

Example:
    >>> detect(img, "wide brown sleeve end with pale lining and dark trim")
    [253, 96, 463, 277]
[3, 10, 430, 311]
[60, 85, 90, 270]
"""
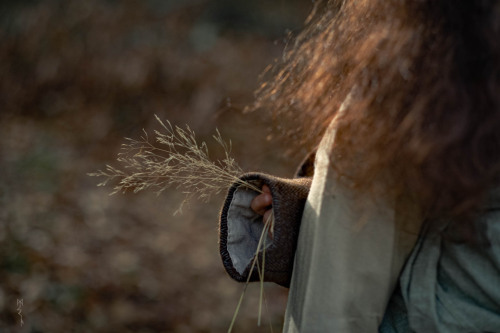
[220, 173, 311, 287]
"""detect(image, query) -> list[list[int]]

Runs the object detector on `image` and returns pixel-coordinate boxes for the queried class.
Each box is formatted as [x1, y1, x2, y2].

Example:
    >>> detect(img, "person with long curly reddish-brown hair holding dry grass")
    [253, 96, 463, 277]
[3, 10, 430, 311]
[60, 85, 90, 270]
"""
[220, 0, 500, 333]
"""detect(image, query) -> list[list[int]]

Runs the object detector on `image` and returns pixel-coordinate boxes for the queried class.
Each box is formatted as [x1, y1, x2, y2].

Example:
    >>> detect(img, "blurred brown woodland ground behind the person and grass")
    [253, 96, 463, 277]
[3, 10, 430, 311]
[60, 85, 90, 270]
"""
[0, 0, 312, 333]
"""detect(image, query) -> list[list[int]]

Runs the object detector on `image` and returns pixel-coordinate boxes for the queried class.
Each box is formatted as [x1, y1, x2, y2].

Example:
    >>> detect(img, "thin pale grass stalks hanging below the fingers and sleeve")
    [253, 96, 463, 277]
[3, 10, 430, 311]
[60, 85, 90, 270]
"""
[228, 212, 274, 333]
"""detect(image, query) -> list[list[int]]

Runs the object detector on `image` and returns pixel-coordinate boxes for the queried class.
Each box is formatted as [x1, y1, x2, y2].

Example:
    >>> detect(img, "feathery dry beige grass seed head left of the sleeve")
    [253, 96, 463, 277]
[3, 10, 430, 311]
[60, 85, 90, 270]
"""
[90, 116, 262, 213]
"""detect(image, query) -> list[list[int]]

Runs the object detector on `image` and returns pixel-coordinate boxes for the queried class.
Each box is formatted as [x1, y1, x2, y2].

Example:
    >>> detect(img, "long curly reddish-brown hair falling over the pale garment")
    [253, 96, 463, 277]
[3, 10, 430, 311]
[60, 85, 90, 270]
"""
[252, 0, 500, 219]
